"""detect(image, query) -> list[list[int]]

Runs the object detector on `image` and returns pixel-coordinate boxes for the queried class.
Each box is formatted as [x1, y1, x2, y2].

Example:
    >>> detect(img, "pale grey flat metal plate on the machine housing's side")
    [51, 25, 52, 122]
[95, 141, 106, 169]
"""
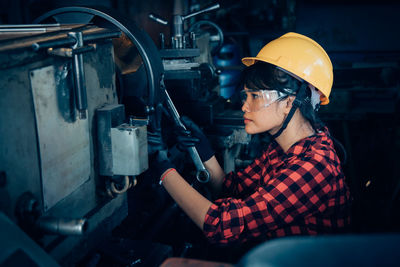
[30, 66, 90, 211]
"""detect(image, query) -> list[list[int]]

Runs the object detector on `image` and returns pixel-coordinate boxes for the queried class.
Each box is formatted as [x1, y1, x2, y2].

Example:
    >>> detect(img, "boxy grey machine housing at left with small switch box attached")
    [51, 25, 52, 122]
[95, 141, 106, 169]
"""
[0, 21, 148, 263]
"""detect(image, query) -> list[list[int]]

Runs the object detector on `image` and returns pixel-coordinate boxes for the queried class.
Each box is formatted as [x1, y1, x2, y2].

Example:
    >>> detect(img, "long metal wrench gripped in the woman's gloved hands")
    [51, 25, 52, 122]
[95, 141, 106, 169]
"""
[164, 90, 210, 183]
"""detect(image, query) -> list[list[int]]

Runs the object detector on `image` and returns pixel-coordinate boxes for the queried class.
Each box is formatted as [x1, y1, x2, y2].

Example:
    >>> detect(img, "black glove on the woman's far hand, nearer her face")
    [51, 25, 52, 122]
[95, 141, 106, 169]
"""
[177, 116, 214, 162]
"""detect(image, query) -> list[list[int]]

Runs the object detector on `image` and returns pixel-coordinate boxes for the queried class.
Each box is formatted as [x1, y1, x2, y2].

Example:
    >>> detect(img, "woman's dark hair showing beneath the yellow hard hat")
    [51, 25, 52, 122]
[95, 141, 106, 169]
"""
[242, 61, 324, 130]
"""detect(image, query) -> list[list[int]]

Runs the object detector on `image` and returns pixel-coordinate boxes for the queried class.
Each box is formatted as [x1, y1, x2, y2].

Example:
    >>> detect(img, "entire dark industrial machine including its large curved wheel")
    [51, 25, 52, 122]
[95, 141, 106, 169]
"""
[0, 5, 250, 266]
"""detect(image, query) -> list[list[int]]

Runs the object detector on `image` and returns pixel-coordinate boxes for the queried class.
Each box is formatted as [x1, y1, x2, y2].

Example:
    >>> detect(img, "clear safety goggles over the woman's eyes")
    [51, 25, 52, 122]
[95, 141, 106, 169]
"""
[240, 89, 287, 112]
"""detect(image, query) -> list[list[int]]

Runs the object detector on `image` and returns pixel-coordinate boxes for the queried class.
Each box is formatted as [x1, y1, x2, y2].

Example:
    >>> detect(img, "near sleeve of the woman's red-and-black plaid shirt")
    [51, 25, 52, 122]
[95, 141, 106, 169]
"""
[203, 147, 349, 244]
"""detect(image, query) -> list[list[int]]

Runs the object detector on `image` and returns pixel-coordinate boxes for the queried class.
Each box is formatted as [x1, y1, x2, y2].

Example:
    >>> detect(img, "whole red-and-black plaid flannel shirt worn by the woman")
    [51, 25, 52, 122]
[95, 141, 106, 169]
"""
[203, 128, 350, 244]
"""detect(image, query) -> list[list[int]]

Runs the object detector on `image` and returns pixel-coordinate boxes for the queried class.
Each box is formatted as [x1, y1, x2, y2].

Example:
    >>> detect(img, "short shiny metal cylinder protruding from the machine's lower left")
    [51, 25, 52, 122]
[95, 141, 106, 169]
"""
[36, 216, 88, 235]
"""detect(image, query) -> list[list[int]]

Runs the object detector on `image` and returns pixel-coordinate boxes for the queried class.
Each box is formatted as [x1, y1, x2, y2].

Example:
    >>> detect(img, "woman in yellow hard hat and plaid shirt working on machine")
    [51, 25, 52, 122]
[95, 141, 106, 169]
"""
[149, 33, 350, 249]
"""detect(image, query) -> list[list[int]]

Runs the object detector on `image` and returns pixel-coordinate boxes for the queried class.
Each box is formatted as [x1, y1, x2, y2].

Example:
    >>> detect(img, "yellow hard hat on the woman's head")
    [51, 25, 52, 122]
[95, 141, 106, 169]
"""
[242, 32, 333, 105]
